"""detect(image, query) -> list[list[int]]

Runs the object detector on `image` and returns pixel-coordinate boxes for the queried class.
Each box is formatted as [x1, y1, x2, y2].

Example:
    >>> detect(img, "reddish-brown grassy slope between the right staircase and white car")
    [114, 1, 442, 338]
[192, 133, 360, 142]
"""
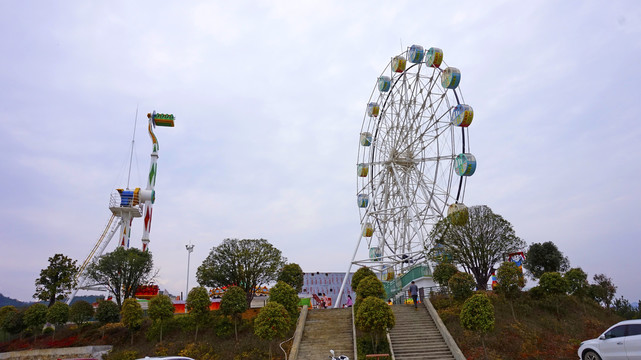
[431, 292, 623, 360]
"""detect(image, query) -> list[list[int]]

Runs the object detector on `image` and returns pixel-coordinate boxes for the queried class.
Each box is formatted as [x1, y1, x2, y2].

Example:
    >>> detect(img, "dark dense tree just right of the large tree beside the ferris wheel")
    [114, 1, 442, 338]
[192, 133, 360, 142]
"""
[523, 241, 570, 279]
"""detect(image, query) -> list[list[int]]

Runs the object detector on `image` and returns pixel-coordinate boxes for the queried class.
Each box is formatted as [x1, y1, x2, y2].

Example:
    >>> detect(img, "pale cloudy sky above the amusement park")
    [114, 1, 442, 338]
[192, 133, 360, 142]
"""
[0, 0, 641, 302]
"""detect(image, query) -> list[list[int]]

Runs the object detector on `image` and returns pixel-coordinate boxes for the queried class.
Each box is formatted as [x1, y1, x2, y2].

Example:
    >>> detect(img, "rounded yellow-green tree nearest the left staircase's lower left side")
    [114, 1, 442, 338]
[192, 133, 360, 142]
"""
[254, 301, 293, 359]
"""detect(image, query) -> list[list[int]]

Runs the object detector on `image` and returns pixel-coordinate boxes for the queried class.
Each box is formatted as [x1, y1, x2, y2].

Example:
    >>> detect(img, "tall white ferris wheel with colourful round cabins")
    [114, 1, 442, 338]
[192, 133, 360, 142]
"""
[341, 45, 476, 304]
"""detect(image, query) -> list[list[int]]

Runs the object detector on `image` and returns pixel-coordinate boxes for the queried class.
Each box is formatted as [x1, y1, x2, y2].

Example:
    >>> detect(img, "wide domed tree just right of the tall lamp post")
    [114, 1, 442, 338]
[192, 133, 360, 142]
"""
[196, 239, 287, 307]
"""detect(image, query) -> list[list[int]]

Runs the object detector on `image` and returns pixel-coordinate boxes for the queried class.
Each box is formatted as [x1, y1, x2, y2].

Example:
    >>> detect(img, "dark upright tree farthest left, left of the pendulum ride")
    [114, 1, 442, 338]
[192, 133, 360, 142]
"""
[33, 254, 78, 306]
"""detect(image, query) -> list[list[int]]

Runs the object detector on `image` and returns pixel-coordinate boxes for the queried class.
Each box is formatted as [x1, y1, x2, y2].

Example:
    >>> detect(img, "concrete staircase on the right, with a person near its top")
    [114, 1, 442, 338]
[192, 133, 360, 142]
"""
[389, 304, 455, 360]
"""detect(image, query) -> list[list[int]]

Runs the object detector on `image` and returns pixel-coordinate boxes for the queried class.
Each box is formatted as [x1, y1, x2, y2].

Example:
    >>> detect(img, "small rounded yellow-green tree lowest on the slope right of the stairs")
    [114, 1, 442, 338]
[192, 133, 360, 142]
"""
[460, 294, 494, 359]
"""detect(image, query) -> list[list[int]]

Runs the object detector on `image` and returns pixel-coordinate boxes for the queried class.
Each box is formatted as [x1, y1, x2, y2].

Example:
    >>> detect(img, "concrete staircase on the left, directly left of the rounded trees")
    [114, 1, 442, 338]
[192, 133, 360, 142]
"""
[297, 308, 354, 360]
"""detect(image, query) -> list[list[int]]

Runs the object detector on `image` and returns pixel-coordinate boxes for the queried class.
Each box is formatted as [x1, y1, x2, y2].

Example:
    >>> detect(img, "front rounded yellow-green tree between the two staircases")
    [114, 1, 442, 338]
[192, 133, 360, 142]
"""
[355, 296, 396, 349]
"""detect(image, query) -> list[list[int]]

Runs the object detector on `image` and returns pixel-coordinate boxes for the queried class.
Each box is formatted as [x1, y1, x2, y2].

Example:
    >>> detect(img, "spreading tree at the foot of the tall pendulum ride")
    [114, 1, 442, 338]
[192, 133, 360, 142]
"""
[87, 247, 154, 308]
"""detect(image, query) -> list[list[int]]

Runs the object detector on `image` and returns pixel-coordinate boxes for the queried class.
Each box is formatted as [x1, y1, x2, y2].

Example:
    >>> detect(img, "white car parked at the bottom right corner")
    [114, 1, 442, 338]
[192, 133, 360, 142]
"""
[578, 319, 641, 360]
